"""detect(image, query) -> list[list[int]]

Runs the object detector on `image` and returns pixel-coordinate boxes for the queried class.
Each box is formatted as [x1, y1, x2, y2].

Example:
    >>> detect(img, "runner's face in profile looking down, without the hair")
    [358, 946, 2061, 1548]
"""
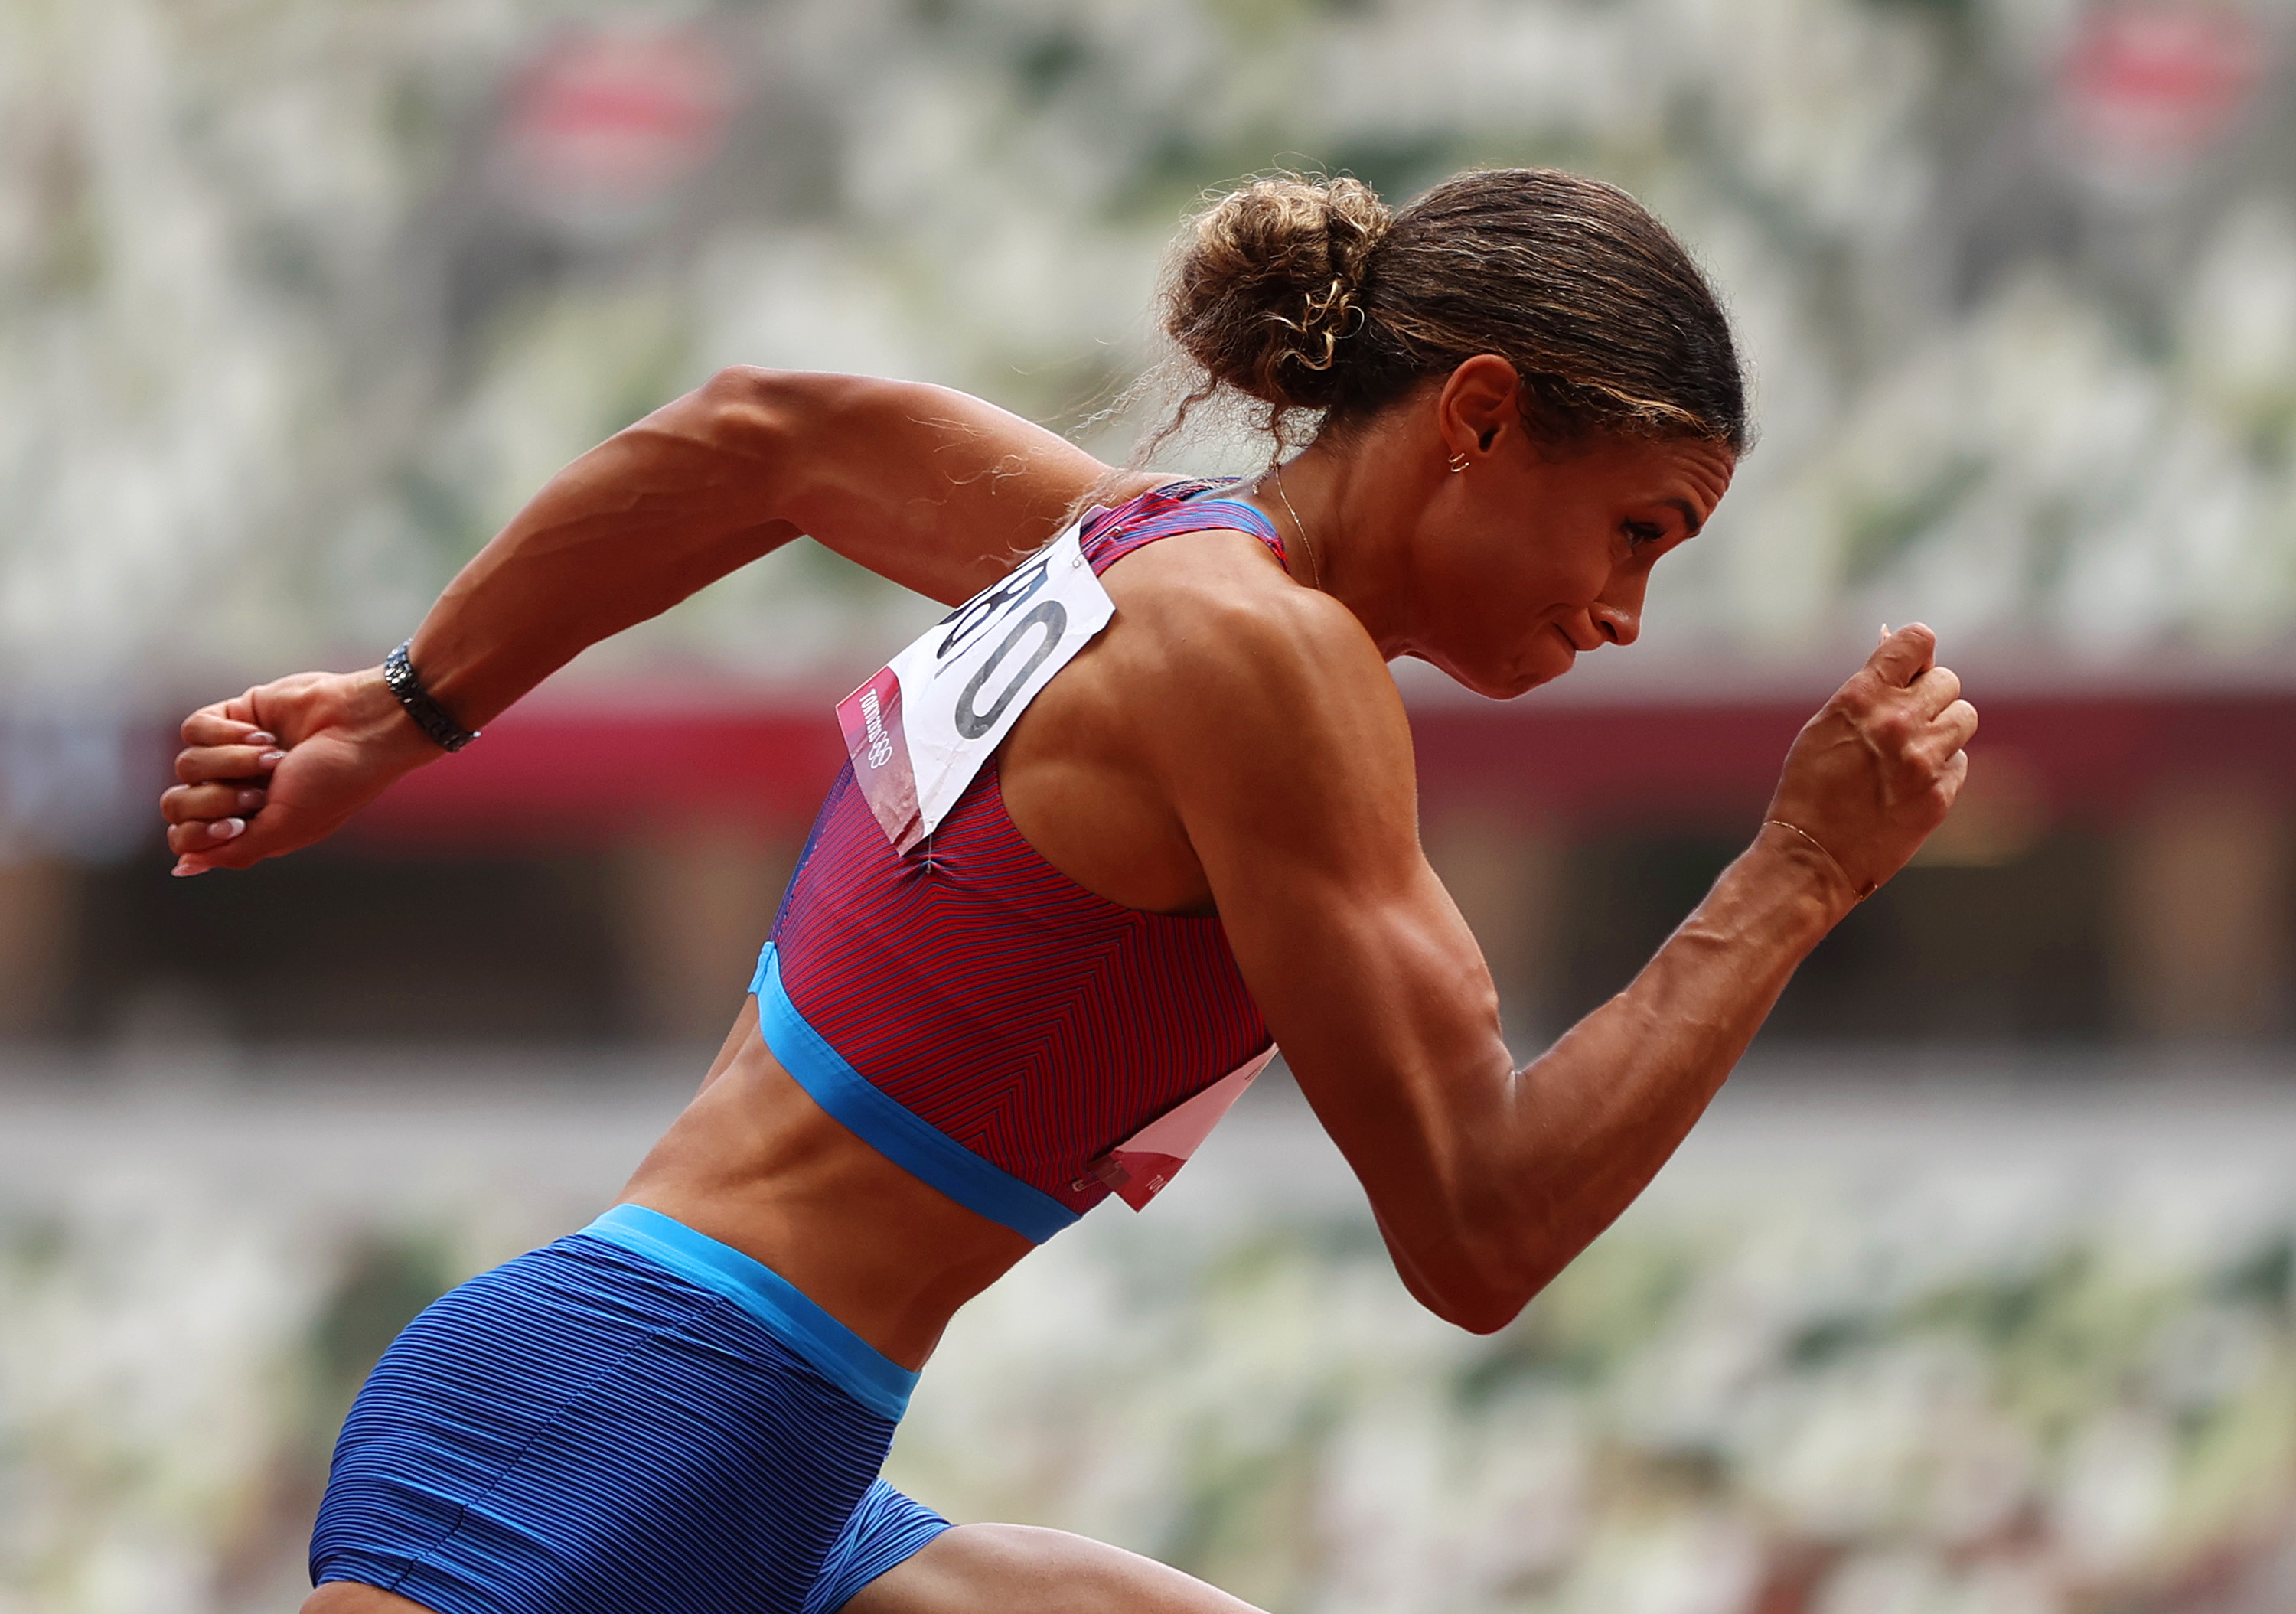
[1410, 429, 1736, 700]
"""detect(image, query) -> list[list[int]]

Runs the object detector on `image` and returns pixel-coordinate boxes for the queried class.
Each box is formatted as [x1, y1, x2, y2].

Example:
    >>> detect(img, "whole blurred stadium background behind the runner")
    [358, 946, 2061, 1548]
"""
[0, 0, 2296, 1614]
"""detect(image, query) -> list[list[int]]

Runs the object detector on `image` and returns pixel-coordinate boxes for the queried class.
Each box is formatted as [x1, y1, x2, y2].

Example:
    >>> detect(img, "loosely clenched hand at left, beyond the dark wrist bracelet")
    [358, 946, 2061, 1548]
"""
[158, 668, 445, 875]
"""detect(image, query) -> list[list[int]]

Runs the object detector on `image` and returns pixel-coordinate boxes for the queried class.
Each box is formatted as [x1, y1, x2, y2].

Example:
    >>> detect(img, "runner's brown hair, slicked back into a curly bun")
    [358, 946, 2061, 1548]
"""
[1153, 168, 1750, 452]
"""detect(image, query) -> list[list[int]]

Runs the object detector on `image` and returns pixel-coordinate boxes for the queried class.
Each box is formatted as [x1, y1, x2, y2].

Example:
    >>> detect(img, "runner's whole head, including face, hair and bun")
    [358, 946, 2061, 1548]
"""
[1164, 168, 1750, 693]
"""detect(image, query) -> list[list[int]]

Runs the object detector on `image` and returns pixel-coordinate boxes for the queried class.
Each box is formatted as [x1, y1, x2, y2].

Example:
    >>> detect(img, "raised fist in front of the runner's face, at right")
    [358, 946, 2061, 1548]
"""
[1768, 624, 1977, 895]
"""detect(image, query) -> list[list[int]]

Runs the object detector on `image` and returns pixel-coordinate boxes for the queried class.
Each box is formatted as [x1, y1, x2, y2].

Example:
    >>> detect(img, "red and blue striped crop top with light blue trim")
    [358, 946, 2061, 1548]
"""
[751, 482, 1283, 1242]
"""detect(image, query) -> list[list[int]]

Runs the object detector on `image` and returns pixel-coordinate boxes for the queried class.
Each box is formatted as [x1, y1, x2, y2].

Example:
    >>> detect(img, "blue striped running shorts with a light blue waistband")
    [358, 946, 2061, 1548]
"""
[310, 1205, 948, 1614]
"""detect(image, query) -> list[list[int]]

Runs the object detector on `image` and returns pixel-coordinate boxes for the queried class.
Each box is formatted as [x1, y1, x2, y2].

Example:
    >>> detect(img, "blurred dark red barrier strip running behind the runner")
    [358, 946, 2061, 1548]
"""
[360, 693, 2296, 845]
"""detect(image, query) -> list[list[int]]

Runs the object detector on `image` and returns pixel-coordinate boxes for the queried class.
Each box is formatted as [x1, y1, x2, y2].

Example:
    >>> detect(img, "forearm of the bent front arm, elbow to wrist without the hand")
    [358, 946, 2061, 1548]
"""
[1492, 827, 1855, 1306]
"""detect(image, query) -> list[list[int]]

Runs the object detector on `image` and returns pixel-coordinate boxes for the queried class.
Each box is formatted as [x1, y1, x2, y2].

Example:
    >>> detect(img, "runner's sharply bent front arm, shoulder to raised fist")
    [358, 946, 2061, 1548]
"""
[1157, 606, 1977, 1332]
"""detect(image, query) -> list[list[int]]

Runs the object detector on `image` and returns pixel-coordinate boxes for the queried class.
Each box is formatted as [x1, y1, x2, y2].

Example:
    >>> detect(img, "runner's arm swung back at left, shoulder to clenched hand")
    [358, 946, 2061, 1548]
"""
[161, 370, 1107, 872]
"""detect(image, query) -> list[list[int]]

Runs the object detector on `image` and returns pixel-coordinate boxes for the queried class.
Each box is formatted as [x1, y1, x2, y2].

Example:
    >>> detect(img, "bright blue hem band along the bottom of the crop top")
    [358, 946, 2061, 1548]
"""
[748, 944, 1077, 1244]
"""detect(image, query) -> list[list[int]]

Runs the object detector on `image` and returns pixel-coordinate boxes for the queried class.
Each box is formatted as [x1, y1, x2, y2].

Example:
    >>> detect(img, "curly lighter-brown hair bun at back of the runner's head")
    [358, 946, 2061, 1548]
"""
[1164, 174, 1396, 413]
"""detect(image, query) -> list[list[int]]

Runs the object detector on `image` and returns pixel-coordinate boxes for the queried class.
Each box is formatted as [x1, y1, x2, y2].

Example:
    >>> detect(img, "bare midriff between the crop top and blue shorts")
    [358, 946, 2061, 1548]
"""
[622, 999, 1035, 1371]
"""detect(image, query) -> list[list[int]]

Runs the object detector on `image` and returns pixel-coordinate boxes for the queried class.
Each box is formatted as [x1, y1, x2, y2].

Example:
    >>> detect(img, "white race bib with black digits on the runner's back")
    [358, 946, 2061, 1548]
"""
[838, 526, 1116, 856]
